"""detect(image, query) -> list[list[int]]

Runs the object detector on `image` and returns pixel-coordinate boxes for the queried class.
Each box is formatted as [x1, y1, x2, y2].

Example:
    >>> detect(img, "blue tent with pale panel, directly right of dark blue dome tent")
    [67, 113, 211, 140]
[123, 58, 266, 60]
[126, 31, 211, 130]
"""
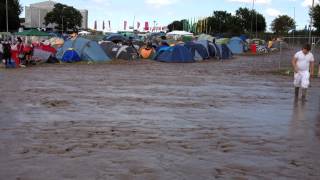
[184, 42, 209, 60]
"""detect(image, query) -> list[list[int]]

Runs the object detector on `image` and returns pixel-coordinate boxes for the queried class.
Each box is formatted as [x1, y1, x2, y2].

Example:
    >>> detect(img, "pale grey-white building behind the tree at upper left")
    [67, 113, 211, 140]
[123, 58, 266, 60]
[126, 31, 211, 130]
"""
[25, 0, 88, 29]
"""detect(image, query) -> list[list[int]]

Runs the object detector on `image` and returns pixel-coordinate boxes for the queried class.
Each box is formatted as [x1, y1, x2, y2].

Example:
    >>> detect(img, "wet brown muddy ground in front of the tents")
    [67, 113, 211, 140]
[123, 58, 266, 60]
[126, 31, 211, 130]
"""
[0, 49, 320, 180]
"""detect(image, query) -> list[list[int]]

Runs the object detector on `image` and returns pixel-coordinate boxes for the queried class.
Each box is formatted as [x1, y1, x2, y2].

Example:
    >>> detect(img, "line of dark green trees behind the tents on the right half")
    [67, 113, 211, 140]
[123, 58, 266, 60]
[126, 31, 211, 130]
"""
[168, 5, 320, 36]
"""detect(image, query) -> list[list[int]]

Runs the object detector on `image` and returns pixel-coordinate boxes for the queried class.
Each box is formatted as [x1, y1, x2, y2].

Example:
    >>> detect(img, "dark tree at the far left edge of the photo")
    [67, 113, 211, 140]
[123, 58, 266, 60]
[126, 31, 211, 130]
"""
[0, 0, 22, 31]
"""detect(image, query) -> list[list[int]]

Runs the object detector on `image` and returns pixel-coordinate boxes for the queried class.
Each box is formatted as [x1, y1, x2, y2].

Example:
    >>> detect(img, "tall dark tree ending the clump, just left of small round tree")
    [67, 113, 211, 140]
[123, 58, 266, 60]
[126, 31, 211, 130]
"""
[236, 8, 267, 33]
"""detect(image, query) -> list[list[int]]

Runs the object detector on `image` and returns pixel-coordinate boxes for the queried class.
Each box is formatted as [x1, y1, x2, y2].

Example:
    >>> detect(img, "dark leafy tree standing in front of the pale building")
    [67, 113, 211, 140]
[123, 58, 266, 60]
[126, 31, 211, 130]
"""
[44, 3, 82, 31]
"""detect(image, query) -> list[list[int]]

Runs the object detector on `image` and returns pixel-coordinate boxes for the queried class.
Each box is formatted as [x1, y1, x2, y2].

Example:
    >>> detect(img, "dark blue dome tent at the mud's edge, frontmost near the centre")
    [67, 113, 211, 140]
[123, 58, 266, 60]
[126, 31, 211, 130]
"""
[154, 45, 195, 63]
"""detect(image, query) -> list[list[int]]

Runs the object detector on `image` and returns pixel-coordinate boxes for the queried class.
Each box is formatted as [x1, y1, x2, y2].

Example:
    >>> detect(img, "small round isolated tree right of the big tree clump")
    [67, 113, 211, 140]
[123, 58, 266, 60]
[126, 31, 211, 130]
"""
[271, 15, 296, 35]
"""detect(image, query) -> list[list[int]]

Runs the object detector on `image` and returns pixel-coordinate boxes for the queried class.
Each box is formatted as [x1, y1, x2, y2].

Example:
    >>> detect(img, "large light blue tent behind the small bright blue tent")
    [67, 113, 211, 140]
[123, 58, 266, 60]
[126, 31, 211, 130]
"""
[57, 37, 111, 62]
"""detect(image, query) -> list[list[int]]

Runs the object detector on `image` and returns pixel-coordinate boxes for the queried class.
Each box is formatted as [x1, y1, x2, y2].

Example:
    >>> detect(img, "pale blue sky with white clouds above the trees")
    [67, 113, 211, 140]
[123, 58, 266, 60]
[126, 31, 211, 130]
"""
[20, 0, 319, 31]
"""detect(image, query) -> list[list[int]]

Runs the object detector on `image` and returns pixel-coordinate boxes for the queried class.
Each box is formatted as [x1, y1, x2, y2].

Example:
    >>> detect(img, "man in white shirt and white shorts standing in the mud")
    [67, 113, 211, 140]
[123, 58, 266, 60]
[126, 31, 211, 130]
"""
[292, 44, 314, 101]
